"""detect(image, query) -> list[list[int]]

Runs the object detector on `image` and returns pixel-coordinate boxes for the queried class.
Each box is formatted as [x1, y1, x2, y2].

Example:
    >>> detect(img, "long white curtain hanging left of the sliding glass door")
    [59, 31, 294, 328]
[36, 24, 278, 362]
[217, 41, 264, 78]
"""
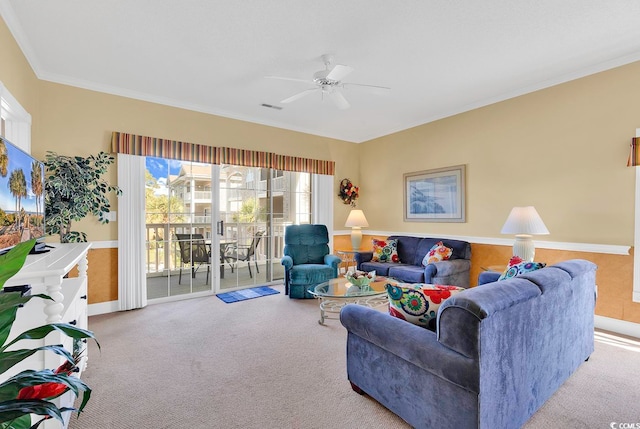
[118, 153, 147, 310]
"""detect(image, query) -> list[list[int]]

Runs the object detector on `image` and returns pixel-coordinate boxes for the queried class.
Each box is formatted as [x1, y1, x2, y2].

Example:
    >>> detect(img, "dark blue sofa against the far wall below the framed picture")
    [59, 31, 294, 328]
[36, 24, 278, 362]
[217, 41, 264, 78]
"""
[355, 235, 471, 288]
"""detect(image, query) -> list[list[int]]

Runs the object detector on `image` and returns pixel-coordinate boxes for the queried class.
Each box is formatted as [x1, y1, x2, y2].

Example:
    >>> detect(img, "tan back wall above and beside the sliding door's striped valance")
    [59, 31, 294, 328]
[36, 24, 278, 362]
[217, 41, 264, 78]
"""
[32, 81, 359, 241]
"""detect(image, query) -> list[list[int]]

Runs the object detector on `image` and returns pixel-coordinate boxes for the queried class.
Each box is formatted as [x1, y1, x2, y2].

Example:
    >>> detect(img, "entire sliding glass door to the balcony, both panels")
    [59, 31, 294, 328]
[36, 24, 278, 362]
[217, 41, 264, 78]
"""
[145, 157, 311, 300]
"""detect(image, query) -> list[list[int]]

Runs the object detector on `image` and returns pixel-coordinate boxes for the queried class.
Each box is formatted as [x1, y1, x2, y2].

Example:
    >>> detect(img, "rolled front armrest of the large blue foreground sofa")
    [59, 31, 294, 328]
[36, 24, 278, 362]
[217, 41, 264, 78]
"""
[340, 304, 479, 392]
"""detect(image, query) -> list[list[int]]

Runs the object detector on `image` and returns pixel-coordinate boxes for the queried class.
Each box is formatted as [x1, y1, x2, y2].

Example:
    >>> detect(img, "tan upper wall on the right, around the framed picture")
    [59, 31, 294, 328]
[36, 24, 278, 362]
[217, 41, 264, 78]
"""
[358, 62, 640, 246]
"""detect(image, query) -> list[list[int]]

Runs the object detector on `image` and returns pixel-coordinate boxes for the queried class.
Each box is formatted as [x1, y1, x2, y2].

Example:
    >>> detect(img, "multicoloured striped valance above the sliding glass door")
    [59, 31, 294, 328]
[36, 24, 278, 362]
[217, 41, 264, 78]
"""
[111, 131, 335, 175]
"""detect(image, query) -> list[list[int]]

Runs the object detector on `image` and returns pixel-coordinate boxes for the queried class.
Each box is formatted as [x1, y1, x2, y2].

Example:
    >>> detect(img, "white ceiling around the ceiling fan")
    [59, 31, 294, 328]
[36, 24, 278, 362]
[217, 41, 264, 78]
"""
[0, 0, 640, 142]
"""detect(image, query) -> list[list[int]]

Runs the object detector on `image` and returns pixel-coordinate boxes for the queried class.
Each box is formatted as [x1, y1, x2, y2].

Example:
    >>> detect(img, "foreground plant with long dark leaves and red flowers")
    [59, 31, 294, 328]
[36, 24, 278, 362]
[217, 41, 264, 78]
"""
[0, 240, 99, 429]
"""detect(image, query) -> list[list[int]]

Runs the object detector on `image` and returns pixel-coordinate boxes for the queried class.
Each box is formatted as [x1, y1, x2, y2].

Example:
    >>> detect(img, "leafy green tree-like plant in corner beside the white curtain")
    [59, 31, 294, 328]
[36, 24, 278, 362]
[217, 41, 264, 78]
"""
[44, 152, 122, 243]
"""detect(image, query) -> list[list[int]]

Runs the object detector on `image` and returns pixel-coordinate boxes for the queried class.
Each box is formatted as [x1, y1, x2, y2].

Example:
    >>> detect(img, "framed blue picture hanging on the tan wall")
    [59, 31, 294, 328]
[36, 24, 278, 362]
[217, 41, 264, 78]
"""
[403, 165, 466, 222]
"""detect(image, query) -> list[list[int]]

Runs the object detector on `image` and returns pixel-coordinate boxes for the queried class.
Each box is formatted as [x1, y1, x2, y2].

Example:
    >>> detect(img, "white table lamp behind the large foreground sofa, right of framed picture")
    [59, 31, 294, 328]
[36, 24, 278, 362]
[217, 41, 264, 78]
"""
[500, 206, 549, 262]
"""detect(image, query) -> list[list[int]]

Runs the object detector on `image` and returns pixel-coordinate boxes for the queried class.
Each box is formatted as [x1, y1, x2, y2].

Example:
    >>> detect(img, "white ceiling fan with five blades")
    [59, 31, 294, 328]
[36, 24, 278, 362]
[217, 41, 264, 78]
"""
[265, 54, 391, 110]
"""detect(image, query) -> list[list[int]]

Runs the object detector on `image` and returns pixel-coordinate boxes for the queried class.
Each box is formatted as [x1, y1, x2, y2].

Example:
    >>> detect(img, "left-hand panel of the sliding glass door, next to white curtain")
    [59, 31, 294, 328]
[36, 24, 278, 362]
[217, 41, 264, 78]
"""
[145, 157, 217, 299]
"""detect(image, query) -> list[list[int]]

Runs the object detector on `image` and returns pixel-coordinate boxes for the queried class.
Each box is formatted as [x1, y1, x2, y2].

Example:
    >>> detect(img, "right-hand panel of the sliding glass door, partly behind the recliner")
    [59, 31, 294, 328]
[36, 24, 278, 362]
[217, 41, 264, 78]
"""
[218, 164, 311, 290]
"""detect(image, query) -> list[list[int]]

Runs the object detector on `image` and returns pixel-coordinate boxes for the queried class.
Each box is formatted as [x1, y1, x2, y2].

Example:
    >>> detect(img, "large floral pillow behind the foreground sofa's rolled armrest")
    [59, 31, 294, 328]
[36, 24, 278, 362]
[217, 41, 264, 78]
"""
[386, 283, 465, 331]
